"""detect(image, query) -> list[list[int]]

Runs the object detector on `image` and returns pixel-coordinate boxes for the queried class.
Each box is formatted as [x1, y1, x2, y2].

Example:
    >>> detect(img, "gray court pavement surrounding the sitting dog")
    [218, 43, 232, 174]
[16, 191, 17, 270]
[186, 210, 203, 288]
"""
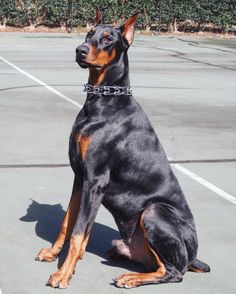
[0, 33, 236, 294]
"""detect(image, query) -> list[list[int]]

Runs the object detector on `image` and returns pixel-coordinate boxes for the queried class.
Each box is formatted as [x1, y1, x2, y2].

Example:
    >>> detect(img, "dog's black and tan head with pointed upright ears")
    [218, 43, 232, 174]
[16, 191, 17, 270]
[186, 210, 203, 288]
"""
[76, 9, 138, 70]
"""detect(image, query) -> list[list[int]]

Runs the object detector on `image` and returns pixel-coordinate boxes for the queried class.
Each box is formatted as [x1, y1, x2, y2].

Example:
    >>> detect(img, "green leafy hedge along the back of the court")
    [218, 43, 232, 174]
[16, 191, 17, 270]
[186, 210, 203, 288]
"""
[0, 0, 236, 31]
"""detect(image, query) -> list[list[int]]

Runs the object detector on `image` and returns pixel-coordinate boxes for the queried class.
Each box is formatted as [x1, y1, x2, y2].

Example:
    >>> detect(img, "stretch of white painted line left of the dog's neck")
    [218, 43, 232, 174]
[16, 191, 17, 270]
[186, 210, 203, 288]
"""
[0, 56, 83, 109]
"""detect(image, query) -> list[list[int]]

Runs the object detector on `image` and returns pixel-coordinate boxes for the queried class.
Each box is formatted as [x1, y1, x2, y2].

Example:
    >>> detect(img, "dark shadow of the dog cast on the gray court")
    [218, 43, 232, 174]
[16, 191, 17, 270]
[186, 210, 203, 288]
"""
[20, 200, 144, 271]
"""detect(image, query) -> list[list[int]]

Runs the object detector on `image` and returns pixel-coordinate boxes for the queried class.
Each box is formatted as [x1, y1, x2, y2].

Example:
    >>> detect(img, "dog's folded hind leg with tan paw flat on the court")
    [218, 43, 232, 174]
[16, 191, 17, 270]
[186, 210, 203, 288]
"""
[115, 205, 187, 288]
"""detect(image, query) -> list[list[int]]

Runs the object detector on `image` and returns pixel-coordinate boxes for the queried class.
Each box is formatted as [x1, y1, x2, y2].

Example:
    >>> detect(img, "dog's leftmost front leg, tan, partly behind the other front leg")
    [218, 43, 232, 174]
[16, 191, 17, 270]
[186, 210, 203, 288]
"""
[35, 178, 81, 262]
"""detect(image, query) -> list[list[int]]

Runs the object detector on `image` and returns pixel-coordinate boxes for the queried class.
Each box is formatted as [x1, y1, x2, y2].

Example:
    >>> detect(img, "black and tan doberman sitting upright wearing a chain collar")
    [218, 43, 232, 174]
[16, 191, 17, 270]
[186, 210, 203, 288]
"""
[36, 9, 210, 288]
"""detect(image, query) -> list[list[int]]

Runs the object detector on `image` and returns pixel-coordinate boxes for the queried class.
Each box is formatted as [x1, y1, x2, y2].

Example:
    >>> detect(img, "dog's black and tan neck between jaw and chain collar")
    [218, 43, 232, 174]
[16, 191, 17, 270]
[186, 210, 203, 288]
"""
[88, 52, 130, 87]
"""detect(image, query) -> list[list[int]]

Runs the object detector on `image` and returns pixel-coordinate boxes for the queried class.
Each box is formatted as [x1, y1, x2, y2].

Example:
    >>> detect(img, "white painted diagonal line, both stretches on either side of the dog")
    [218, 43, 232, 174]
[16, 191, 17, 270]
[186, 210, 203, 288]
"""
[0, 56, 236, 204]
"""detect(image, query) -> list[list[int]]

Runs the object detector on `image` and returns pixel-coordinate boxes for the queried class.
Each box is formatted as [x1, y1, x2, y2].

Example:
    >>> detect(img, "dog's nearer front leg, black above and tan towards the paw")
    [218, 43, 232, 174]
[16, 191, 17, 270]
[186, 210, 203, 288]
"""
[47, 174, 109, 288]
